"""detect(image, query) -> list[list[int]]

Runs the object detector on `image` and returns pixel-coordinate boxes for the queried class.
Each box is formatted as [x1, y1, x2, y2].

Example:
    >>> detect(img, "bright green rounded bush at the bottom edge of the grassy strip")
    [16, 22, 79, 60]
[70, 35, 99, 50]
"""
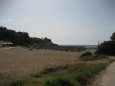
[41, 77, 81, 86]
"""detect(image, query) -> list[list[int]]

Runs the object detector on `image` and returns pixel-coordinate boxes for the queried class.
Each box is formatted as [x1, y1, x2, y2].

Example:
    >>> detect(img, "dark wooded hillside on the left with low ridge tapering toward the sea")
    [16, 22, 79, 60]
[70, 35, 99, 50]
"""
[0, 26, 85, 51]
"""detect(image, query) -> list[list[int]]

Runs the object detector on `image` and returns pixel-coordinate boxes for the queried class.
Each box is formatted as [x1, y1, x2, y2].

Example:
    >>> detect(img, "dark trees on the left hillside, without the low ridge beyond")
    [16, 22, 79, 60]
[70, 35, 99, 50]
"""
[0, 26, 52, 46]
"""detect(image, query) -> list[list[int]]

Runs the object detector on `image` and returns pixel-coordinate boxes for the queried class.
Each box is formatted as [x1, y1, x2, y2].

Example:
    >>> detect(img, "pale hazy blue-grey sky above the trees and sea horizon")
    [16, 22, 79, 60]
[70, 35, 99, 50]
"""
[0, 0, 115, 45]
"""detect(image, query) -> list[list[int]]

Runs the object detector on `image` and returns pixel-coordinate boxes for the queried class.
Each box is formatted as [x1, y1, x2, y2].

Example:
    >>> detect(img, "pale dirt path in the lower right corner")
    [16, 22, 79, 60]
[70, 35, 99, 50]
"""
[91, 62, 115, 86]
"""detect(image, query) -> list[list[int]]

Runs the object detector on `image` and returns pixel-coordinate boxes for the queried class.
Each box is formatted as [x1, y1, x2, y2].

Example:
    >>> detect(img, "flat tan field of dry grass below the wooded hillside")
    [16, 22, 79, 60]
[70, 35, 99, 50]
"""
[0, 47, 83, 86]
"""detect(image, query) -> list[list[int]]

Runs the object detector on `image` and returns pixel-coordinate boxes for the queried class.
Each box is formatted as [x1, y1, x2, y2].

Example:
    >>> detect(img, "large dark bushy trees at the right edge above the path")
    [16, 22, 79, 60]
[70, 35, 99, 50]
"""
[96, 32, 115, 56]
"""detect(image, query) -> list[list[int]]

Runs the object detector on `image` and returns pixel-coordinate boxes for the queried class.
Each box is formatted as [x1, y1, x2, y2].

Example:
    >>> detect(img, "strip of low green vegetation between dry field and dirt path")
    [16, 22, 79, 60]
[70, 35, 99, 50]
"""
[11, 60, 113, 86]
